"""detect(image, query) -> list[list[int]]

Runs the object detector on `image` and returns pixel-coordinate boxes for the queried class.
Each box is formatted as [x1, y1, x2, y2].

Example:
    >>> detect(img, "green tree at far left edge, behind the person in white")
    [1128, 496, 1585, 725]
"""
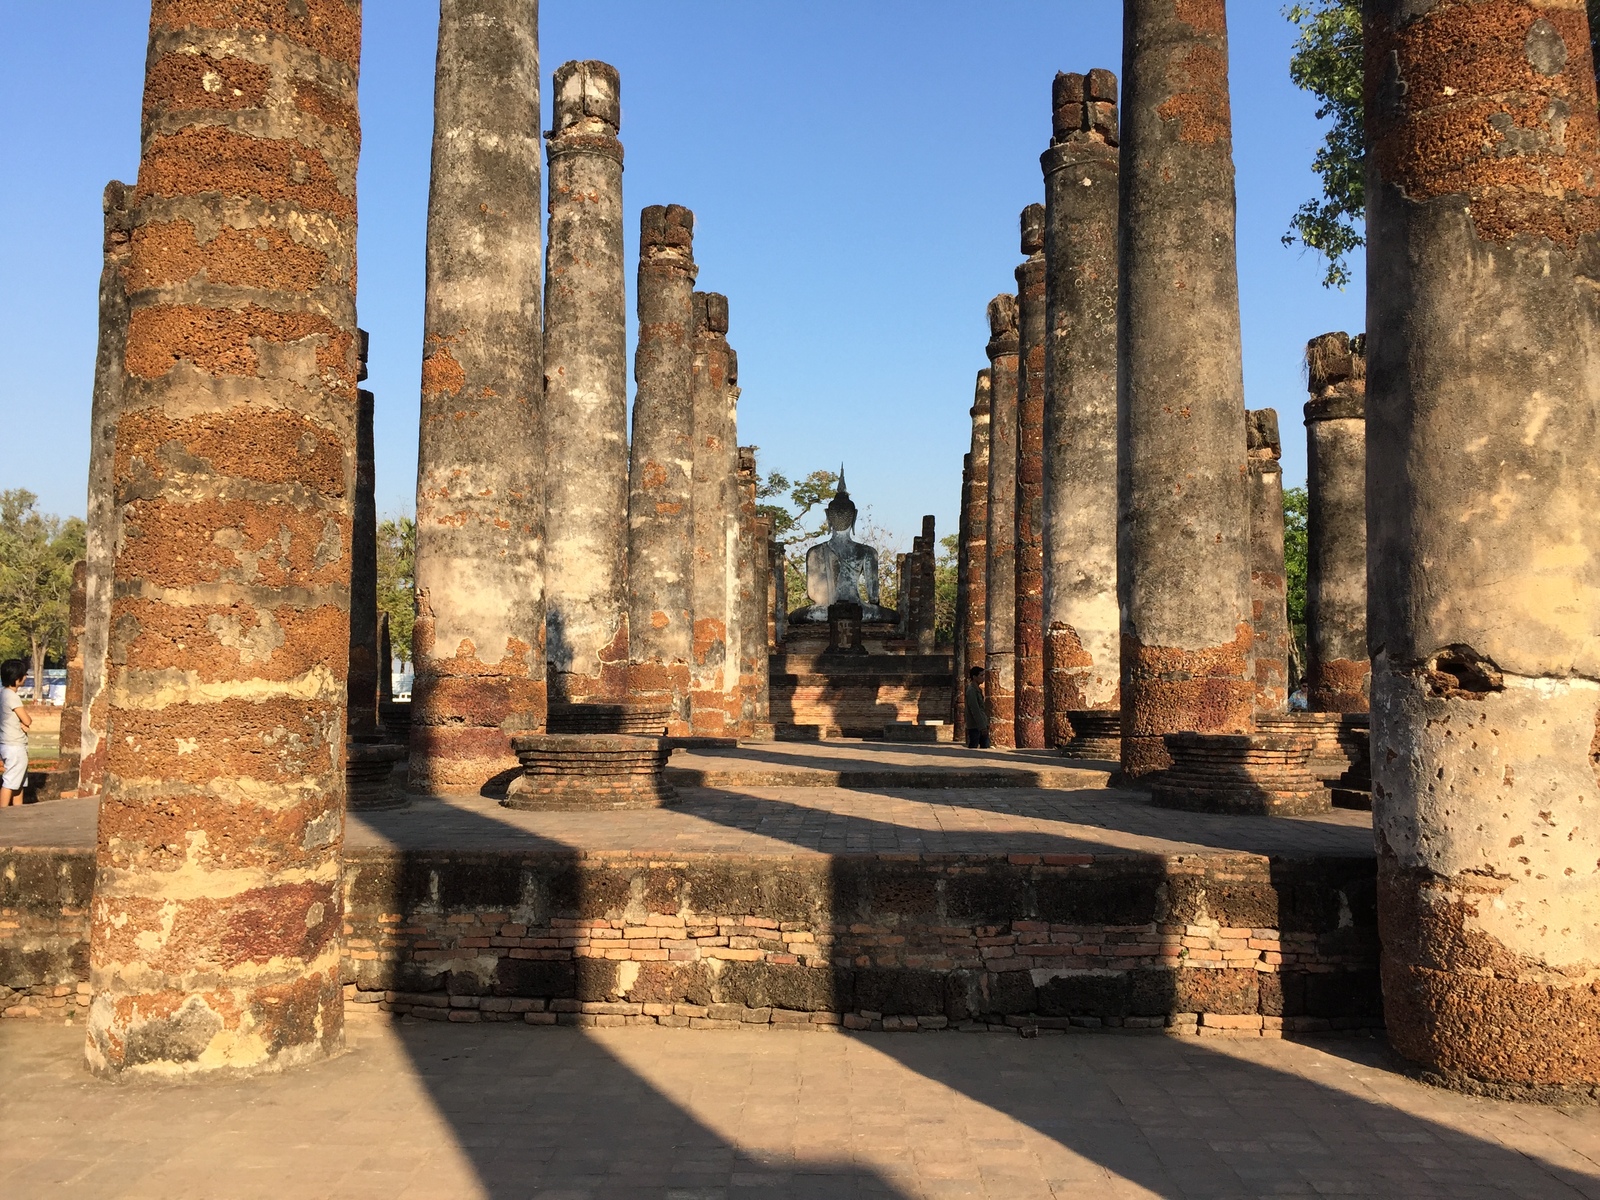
[0, 488, 85, 701]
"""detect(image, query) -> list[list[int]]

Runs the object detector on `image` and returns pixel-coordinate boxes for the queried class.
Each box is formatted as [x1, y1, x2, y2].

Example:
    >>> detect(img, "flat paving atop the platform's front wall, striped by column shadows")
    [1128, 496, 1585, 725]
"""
[0, 787, 1373, 858]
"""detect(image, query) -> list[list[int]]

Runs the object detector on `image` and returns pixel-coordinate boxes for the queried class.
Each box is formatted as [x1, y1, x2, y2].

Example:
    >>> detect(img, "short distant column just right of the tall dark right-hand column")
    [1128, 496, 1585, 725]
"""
[1245, 408, 1290, 717]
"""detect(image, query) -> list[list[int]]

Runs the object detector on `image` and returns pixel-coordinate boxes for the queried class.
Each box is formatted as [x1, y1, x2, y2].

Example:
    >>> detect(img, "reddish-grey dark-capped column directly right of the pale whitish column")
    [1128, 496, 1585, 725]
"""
[627, 205, 696, 738]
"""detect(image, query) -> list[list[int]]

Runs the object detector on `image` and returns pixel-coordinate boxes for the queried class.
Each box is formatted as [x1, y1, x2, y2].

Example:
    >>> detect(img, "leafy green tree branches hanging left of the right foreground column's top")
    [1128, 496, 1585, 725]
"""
[1283, 0, 1356, 288]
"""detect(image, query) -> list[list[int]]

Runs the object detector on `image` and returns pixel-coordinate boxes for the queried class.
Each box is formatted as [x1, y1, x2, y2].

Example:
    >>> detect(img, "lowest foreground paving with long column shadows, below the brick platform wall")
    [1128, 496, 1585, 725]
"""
[0, 1019, 1600, 1200]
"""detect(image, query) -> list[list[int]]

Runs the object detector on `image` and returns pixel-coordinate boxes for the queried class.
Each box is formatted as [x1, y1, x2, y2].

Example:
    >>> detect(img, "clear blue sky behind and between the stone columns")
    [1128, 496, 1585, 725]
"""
[0, 0, 1365, 547]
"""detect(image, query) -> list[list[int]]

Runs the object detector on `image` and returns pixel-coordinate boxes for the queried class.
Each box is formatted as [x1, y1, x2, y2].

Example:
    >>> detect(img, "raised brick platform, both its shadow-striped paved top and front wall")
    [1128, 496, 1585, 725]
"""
[0, 747, 1378, 1035]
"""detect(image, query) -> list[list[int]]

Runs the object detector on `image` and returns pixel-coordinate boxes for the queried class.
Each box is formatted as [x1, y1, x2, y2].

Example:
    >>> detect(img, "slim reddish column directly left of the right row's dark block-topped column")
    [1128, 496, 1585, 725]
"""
[1016, 205, 1045, 749]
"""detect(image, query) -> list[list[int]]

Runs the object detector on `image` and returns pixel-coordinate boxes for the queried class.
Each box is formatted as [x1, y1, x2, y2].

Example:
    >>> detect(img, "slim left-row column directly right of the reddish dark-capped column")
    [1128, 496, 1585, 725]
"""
[690, 291, 739, 738]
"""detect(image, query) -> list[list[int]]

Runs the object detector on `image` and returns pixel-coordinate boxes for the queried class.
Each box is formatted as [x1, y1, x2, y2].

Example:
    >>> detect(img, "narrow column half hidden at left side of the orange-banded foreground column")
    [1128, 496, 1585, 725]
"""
[69, 179, 133, 795]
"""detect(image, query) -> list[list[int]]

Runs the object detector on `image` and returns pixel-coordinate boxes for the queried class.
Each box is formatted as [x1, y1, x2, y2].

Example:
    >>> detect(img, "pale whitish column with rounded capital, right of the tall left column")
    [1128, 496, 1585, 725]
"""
[544, 62, 627, 704]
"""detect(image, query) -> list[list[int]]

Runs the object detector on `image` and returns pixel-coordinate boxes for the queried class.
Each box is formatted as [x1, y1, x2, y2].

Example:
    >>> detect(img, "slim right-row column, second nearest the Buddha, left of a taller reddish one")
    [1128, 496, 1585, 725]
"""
[984, 294, 1018, 746]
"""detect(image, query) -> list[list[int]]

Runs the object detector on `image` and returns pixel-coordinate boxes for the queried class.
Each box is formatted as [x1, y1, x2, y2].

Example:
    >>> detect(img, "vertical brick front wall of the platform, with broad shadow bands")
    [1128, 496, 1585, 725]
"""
[0, 848, 1382, 1037]
